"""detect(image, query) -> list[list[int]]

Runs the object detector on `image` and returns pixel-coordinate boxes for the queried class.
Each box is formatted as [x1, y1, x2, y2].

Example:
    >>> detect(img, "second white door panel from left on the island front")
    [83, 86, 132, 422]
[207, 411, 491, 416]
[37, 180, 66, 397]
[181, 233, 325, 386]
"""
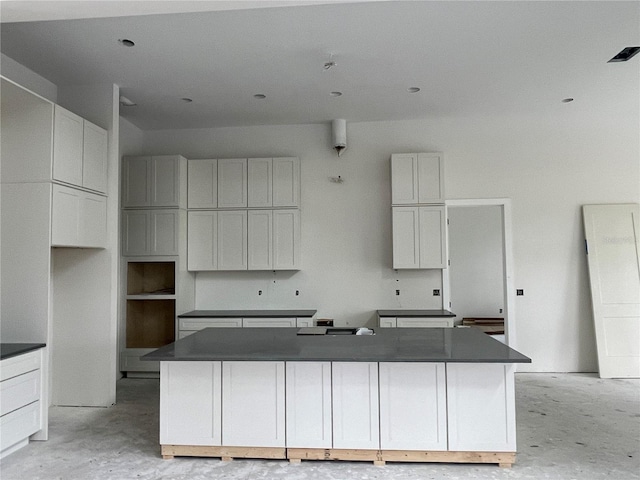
[222, 362, 285, 447]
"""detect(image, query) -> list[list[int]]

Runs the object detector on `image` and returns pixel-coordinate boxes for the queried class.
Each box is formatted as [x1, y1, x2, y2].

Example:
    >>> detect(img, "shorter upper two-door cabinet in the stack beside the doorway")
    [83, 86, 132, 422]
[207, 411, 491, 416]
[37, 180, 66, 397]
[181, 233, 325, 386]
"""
[391, 153, 444, 205]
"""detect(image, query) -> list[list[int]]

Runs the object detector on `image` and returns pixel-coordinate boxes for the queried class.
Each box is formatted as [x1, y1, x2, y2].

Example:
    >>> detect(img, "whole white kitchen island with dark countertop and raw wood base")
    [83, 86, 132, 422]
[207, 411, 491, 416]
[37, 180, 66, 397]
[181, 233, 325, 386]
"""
[143, 328, 531, 467]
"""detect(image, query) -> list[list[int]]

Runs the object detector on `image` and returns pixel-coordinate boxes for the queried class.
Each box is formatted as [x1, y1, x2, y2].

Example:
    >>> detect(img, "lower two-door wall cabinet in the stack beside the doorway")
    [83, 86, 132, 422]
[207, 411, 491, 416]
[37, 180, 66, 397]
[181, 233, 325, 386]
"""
[392, 205, 446, 269]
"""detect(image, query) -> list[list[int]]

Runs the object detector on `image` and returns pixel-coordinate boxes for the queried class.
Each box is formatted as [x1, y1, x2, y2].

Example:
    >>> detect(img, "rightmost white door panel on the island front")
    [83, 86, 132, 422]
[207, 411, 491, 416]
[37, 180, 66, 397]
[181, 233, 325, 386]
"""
[446, 363, 516, 452]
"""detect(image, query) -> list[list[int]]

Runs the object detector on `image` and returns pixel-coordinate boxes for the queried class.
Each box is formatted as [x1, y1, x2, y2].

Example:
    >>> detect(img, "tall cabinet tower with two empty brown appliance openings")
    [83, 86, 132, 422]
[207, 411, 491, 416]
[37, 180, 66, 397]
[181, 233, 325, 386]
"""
[120, 155, 195, 376]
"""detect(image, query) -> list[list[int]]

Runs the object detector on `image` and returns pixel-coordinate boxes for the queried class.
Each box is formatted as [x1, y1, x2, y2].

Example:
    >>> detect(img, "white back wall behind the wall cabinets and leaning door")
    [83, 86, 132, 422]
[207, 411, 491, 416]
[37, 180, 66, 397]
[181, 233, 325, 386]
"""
[145, 103, 640, 371]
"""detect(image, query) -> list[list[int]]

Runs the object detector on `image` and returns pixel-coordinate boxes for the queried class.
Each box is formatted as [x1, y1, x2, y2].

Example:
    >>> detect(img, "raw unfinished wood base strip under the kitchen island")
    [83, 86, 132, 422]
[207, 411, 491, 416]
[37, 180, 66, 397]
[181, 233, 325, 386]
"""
[161, 445, 516, 468]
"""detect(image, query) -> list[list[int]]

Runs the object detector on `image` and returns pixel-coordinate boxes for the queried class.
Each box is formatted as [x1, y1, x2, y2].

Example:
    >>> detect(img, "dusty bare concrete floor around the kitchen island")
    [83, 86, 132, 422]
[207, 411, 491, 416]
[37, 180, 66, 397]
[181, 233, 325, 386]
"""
[0, 373, 640, 480]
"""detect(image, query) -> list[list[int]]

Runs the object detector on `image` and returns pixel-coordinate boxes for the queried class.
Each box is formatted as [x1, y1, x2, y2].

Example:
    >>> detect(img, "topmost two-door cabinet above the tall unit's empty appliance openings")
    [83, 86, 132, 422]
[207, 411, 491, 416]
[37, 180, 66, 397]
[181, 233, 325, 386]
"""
[122, 155, 187, 208]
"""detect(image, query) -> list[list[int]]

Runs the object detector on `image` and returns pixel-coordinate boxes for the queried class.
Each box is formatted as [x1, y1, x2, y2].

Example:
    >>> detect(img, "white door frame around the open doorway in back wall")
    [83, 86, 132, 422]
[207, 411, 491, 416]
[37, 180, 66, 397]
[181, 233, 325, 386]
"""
[442, 198, 517, 348]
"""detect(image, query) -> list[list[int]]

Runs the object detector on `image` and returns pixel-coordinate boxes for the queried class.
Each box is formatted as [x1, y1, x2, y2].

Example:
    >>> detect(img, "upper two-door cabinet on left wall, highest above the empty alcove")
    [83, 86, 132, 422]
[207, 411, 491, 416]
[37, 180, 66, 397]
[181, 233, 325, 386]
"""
[53, 105, 108, 193]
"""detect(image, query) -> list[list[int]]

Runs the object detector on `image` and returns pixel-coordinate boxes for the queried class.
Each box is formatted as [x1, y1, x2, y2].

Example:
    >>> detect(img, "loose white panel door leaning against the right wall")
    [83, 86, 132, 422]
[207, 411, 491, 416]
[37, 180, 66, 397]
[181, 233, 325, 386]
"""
[583, 204, 640, 378]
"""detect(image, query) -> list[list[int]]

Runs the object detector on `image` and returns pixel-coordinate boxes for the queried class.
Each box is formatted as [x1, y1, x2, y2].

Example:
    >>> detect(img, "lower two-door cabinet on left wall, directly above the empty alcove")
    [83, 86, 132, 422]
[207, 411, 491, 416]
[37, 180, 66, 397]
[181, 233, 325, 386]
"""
[51, 184, 107, 248]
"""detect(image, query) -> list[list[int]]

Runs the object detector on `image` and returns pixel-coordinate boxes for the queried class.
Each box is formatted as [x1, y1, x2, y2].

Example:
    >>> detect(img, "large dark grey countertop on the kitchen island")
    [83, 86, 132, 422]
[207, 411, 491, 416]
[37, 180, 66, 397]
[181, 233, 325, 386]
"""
[141, 328, 531, 363]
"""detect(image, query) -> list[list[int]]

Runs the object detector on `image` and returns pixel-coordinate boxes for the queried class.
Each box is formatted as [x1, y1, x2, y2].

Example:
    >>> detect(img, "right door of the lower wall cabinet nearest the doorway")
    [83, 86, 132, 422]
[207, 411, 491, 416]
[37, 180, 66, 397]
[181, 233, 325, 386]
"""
[418, 206, 447, 268]
